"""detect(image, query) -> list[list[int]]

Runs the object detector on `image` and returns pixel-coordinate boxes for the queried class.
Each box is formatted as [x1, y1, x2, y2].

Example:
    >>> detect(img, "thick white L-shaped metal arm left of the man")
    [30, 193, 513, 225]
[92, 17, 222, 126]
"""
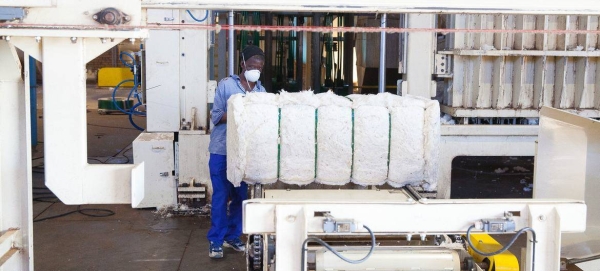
[42, 38, 133, 204]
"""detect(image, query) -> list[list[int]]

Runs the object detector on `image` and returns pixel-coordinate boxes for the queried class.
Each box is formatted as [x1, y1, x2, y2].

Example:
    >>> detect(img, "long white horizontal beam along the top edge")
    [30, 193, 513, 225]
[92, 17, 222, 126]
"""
[142, 0, 600, 14]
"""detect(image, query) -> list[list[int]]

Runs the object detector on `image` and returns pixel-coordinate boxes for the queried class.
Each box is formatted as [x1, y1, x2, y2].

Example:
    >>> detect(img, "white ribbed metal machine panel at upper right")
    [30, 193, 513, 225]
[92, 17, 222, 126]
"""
[440, 14, 600, 117]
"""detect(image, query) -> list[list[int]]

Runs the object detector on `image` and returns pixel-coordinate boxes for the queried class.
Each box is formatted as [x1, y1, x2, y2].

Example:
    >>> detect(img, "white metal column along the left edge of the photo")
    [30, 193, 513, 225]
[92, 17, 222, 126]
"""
[0, 40, 33, 270]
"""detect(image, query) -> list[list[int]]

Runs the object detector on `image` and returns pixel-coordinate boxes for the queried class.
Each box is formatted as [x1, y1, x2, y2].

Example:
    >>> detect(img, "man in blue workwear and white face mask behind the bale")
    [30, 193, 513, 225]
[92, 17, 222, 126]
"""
[207, 45, 265, 259]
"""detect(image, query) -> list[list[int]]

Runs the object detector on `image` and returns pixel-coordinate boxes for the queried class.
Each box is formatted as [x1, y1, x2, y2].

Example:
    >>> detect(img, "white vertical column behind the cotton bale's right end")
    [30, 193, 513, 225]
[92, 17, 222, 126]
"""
[406, 14, 437, 98]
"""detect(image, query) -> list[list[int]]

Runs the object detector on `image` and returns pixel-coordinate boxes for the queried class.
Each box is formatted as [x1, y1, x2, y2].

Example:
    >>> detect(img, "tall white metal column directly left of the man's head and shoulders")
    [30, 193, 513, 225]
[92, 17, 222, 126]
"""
[145, 9, 211, 132]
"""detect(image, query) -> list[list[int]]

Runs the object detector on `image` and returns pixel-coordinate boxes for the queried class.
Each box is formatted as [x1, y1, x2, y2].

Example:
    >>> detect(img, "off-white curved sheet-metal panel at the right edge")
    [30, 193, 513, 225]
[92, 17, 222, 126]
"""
[533, 107, 600, 270]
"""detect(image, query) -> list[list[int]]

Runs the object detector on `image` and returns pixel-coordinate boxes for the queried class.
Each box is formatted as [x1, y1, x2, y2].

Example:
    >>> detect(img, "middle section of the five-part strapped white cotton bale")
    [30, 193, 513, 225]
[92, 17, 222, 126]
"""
[317, 105, 352, 185]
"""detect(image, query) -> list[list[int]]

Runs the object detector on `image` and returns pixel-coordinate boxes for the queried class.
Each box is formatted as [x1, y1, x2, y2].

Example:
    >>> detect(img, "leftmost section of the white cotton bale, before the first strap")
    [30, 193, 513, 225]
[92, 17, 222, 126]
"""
[227, 93, 279, 186]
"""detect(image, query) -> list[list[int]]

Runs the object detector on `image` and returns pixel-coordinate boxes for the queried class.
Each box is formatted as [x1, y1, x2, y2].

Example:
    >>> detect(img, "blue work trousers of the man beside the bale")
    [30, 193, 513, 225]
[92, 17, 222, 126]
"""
[206, 153, 248, 244]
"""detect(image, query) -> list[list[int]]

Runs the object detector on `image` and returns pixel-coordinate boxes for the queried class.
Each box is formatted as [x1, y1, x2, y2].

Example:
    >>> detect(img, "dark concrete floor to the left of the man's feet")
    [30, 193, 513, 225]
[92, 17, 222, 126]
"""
[33, 88, 246, 271]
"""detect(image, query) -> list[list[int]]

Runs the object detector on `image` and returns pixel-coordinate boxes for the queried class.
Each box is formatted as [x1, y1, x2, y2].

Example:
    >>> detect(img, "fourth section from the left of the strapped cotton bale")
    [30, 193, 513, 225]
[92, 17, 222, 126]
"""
[352, 105, 389, 185]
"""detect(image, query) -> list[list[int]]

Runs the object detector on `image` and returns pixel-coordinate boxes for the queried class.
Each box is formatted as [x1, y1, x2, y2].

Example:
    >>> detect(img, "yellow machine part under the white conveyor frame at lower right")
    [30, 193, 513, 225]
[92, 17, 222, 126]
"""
[467, 233, 519, 271]
